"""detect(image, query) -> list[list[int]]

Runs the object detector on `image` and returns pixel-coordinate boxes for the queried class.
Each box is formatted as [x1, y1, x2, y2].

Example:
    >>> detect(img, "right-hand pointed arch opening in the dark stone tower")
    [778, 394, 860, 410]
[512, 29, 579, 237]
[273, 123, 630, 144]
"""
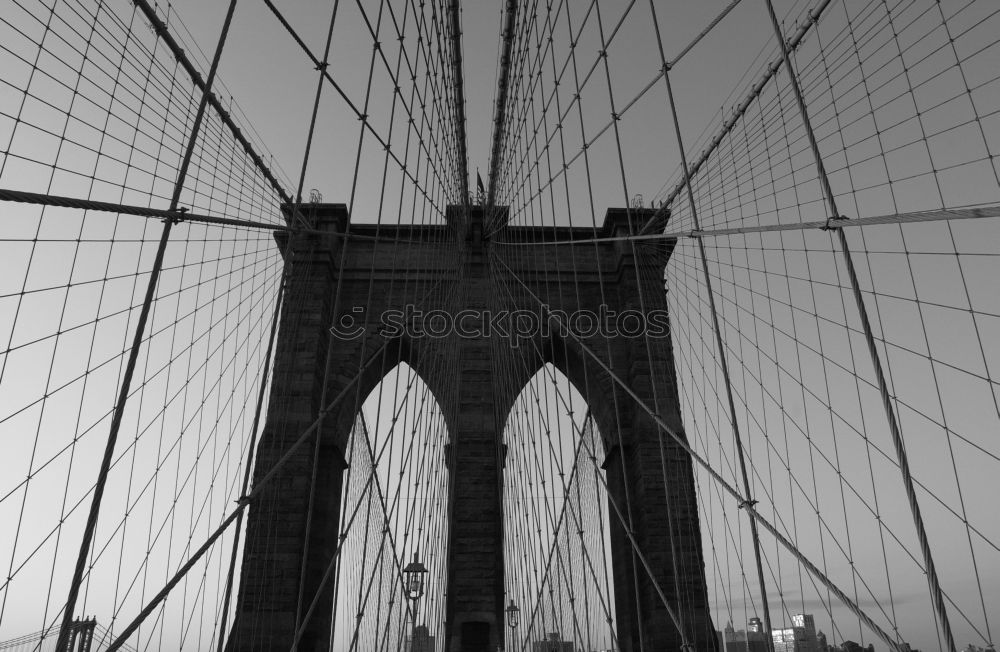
[503, 362, 620, 650]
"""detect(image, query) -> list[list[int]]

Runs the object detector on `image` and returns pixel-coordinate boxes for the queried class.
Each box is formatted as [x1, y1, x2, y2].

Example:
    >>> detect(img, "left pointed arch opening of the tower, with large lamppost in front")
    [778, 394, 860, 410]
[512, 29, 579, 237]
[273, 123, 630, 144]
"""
[331, 361, 449, 650]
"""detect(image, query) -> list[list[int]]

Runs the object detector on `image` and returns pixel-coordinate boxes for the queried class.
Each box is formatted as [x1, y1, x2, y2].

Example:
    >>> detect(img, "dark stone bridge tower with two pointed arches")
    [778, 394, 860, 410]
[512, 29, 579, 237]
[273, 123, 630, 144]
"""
[227, 204, 716, 652]
